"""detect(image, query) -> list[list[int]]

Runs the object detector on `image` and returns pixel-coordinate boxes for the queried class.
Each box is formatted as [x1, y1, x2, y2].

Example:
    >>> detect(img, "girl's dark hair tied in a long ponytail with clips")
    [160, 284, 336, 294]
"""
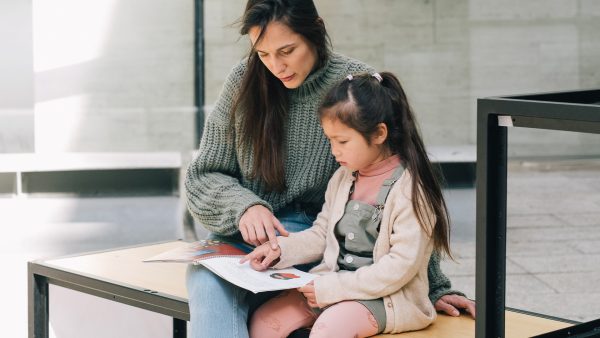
[319, 72, 452, 257]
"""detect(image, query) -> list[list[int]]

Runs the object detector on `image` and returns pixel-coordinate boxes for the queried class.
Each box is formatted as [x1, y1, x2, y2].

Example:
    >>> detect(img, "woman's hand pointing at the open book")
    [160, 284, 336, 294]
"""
[239, 204, 289, 249]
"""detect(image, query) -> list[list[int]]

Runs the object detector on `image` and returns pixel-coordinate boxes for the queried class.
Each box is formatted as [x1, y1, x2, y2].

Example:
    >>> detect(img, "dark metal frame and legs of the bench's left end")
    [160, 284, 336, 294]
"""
[27, 244, 190, 338]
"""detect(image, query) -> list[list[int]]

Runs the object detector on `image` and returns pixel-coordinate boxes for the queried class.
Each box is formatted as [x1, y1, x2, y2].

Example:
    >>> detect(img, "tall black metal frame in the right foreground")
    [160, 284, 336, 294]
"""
[475, 89, 600, 338]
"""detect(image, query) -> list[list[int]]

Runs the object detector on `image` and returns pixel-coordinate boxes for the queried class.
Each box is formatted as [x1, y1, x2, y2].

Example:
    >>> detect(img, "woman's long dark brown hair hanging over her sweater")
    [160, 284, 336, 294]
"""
[231, 0, 330, 191]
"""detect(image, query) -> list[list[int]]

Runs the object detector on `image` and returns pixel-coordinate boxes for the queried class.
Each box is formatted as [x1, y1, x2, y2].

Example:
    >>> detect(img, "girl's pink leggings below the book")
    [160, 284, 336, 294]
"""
[249, 290, 378, 338]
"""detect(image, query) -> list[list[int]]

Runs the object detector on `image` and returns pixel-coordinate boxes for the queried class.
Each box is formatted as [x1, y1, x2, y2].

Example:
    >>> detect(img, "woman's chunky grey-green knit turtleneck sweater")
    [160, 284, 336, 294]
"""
[185, 54, 464, 302]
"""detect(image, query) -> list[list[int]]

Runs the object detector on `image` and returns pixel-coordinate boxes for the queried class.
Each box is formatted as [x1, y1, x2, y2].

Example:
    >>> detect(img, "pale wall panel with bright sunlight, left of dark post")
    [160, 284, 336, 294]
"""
[33, 0, 195, 152]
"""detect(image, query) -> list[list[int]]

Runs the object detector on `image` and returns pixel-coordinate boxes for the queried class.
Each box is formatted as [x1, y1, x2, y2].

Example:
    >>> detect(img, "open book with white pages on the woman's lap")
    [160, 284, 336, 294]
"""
[144, 239, 317, 293]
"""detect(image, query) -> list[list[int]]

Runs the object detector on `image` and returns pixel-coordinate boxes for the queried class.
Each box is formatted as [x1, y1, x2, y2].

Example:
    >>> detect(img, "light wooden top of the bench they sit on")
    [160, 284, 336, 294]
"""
[38, 241, 571, 338]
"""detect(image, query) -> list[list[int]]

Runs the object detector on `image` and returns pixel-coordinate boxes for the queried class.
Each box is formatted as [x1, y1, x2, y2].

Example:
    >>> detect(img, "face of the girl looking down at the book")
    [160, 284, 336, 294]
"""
[321, 117, 389, 171]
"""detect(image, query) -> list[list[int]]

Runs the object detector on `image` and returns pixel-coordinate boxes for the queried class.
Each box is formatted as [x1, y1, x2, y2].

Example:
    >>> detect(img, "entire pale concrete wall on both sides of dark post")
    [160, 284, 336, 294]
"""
[0, 0, 600, 156]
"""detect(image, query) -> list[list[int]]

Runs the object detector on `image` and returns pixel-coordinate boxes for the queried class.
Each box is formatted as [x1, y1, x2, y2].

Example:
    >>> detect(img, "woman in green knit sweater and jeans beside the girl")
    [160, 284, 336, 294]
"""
[185, 0, 475, 337]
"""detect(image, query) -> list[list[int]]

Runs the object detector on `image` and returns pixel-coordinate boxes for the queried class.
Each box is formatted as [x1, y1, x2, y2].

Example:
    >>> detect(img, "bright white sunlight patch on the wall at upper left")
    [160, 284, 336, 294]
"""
[33, 0, 116, 152]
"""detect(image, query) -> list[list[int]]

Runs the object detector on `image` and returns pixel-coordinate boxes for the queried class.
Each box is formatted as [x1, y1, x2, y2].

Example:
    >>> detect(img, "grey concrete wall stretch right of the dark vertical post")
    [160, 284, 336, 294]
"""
[205, 0, 600, 156]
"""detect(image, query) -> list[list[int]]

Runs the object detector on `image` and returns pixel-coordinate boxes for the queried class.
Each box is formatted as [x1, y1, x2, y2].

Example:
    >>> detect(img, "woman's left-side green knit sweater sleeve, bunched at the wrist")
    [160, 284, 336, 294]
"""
[185, 63, 271, 235]
